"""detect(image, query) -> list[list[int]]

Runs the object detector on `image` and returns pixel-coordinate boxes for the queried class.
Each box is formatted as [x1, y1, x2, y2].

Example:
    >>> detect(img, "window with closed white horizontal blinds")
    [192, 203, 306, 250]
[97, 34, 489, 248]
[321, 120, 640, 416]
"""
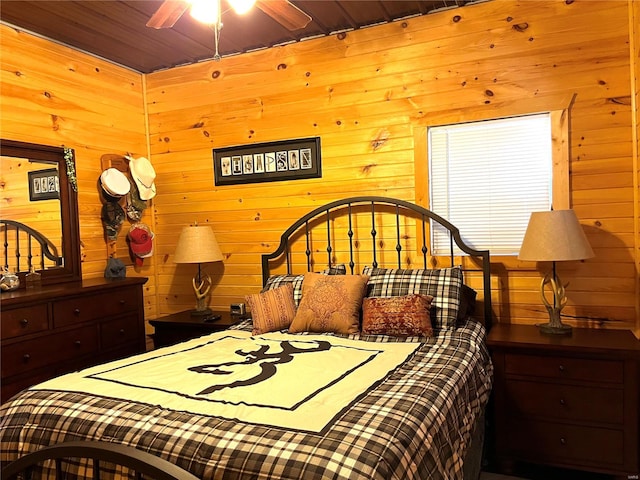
[428, 113, 553, 255]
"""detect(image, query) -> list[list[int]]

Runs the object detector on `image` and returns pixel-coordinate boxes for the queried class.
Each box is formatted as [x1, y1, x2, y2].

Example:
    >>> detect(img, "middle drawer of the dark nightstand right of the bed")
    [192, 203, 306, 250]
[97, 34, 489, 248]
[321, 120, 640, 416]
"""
[505, 379, 624, 424]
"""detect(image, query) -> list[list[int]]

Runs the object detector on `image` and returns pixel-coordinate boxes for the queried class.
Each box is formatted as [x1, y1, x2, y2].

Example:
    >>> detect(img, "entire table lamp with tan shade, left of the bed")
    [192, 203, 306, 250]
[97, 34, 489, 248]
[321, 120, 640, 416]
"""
[173, 223, 223, 316]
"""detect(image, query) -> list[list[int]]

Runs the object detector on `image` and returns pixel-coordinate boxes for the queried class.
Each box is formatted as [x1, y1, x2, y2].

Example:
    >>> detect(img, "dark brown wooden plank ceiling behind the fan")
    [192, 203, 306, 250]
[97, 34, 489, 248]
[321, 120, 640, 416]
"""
[0, 0, 472, 73]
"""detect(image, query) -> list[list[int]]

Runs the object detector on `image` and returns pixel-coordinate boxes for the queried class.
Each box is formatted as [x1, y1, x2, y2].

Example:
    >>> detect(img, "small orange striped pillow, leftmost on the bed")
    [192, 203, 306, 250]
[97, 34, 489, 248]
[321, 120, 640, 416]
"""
[244, 283, 296, 335]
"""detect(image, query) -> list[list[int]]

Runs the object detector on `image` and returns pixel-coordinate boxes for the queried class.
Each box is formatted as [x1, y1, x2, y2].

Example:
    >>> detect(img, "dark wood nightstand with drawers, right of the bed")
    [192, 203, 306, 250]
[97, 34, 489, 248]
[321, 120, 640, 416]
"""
[487, 324, 640, 478]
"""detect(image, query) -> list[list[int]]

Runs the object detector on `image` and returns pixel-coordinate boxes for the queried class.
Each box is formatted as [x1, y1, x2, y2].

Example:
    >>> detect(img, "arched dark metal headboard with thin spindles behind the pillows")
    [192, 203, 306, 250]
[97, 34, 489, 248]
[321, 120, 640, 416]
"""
[262, 196, 492, 328]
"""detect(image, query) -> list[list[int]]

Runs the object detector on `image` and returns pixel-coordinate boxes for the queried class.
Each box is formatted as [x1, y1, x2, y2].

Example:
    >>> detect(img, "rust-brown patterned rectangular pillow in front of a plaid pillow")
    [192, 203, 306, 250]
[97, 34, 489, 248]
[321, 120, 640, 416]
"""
[362, 293, 433, 337]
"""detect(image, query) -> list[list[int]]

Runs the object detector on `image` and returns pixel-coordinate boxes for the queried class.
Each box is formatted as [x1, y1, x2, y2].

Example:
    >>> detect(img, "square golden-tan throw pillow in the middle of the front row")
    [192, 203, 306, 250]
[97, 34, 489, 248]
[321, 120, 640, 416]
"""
[289, 273, 369, 334]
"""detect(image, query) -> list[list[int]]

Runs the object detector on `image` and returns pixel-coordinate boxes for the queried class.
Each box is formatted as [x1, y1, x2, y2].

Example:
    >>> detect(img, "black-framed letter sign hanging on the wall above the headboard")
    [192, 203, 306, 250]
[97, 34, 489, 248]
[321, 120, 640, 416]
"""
[213, 137, 322, 185]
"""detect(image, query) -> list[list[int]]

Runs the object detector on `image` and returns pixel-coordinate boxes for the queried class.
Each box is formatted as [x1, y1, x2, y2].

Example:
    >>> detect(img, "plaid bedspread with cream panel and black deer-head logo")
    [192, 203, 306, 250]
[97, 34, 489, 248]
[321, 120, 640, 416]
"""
[0, 321, 493, 480]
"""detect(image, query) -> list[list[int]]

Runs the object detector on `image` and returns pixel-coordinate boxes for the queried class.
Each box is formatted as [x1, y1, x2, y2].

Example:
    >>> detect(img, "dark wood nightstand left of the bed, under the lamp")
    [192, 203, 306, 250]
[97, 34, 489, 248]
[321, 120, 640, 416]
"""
[149, 310, 248, 348]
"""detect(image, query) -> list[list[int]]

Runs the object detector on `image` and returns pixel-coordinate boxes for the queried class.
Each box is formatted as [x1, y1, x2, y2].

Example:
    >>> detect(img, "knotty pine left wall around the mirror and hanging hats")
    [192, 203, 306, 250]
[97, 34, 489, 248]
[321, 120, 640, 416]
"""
[0, 25, 157, 326]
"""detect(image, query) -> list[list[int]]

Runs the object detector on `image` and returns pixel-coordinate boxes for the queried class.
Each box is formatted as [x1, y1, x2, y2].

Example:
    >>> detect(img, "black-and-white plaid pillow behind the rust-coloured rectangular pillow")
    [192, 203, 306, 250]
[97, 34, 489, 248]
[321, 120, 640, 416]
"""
[362, 267, 462, 329]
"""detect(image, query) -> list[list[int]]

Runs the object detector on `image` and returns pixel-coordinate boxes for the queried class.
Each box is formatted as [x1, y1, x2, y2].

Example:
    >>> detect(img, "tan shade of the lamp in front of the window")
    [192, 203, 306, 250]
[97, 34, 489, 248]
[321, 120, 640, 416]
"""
[518, 210, 594, 262]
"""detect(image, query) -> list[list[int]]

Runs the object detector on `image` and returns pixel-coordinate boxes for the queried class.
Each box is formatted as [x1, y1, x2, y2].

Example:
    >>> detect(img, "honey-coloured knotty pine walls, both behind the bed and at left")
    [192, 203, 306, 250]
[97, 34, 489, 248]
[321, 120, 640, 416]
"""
[2, 0, 640, 331]
